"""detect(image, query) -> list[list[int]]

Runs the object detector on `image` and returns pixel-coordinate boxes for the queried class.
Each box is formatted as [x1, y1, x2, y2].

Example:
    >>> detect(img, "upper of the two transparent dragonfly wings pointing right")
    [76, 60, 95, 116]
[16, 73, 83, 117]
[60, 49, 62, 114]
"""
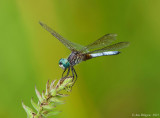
[80, 34, 117, 52]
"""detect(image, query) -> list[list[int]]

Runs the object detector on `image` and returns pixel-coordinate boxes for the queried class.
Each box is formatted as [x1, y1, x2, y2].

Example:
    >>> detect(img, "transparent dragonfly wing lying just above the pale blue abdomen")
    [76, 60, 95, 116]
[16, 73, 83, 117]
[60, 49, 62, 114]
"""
[88, 42, 129, 54]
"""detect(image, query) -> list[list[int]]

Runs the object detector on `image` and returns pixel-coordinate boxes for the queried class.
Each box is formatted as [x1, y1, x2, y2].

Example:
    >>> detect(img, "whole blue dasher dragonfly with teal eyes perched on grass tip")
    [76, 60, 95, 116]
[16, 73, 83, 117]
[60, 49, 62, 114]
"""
[39, 22, 129, 82]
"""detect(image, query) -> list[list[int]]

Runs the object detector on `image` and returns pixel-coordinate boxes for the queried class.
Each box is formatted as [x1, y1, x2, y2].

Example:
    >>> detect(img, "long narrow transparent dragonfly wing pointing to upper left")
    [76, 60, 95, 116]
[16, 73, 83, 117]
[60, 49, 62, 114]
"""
[39, 22, 84, 51]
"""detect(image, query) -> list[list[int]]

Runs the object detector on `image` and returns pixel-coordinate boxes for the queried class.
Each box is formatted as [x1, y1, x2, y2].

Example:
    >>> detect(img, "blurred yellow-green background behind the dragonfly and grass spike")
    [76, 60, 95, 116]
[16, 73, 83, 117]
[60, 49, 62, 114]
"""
[0, 0, 160, 118]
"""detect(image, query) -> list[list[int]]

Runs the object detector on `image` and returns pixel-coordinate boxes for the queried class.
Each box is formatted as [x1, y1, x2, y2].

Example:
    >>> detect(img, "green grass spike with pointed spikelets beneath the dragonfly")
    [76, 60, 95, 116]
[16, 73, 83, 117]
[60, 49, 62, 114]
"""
[22, 76, 73, 118]
